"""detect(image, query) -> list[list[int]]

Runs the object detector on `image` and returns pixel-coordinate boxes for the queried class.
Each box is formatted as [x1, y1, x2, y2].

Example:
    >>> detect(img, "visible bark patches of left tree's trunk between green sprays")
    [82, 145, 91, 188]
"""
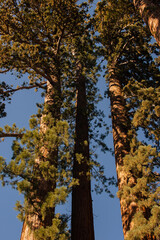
[20, 77, 61, 240]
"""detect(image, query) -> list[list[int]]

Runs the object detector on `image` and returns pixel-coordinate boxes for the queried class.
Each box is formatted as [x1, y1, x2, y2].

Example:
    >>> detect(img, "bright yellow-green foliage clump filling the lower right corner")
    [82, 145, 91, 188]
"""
[118, 141, 160, 240]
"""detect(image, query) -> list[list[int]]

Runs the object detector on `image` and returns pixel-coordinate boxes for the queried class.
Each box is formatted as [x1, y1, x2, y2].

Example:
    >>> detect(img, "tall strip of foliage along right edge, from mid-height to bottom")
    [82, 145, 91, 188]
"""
[122, 76, 160, 239]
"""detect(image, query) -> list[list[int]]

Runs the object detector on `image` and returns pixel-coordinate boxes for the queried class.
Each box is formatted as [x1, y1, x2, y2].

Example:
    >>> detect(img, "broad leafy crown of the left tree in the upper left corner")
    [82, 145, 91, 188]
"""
[0, 0, 88, 82]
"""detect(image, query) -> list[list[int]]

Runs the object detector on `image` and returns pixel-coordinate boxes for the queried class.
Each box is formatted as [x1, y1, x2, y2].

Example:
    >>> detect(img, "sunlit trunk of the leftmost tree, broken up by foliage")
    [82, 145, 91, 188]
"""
[21, 76, 61, 240]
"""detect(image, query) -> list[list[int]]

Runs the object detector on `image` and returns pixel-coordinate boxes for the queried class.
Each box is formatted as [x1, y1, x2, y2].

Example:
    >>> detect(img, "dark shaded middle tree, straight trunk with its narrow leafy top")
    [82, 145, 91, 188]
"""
[71, 34, 96, 240]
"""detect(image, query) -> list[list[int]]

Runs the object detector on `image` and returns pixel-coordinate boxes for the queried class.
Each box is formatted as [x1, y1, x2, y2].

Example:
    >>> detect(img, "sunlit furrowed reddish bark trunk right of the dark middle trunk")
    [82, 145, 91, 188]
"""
[109, 70, 136, 238]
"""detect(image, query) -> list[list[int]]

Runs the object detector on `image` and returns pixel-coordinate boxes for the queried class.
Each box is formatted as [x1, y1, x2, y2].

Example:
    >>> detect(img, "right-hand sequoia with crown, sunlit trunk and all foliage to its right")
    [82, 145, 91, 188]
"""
[96, 1, 159, 239]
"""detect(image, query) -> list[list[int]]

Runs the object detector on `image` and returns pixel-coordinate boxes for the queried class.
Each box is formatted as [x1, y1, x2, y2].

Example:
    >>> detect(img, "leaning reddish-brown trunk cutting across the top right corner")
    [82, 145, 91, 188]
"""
[133, 0, 160, 46]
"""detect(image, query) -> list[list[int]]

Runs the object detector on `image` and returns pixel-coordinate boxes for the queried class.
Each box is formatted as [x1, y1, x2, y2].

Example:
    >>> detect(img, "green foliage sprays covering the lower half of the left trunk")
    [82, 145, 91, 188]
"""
[1, 113, 73, 232]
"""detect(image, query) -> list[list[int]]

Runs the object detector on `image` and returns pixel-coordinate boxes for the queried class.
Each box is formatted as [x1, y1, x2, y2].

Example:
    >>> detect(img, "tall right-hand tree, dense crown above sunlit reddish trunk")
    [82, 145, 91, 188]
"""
[96, 1, 159, 239]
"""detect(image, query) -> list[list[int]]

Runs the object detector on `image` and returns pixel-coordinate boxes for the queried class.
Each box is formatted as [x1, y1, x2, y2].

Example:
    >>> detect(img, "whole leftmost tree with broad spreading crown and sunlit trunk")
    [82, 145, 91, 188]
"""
[0, 1, 90, 240]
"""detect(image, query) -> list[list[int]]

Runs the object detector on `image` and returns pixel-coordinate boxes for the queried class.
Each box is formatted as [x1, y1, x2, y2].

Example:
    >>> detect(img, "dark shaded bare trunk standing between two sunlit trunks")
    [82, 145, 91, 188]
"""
[71, 65, 94, 240]
